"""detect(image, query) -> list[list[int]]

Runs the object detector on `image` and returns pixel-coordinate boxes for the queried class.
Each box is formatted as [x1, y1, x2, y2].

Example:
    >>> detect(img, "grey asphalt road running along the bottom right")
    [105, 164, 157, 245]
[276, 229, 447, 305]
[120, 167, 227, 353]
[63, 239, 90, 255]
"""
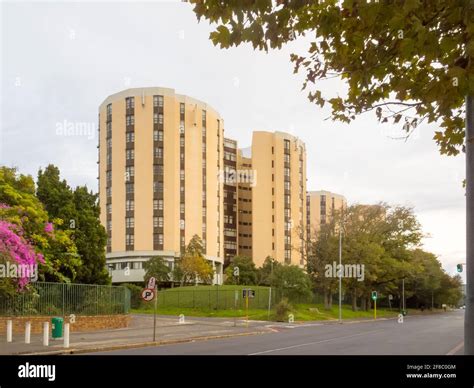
[94, 310, 464, 355]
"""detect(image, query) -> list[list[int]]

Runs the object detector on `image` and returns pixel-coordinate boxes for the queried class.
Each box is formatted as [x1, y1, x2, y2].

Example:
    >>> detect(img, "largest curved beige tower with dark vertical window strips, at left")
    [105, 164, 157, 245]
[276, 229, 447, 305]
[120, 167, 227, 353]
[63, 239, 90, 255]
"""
[99, 88, 224, 283]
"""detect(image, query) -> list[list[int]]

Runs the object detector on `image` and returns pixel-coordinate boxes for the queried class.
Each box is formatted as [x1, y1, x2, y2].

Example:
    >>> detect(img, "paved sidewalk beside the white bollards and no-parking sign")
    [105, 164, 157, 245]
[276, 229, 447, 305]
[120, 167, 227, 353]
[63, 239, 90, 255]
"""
[0, 314, 272, 355]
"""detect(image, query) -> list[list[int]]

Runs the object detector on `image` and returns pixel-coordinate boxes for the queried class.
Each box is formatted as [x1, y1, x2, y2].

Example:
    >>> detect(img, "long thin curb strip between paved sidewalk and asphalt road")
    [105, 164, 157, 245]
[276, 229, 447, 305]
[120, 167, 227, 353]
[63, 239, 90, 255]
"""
[12, 331, 270, 356]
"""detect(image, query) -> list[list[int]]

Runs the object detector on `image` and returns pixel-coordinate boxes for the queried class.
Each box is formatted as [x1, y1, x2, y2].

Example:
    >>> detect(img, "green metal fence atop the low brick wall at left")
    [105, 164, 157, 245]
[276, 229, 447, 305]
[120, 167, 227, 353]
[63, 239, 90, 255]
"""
[0, 282, 130, 316]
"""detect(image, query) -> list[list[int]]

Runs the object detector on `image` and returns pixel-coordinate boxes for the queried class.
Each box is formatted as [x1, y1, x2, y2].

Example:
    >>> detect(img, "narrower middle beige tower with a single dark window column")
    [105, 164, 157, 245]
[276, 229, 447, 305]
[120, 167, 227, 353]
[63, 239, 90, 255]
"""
[251, 131, 306, 266]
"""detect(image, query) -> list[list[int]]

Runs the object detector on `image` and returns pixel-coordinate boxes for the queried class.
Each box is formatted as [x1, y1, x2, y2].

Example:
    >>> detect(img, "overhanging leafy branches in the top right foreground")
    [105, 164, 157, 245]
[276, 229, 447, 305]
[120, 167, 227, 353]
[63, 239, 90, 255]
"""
[191, 0, 474, 155]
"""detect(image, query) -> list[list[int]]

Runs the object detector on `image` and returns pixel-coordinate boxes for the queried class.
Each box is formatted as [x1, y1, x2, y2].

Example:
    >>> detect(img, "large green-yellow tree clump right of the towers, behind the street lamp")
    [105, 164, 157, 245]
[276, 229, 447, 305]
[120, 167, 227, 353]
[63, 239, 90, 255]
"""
[307, 203, 460, 310]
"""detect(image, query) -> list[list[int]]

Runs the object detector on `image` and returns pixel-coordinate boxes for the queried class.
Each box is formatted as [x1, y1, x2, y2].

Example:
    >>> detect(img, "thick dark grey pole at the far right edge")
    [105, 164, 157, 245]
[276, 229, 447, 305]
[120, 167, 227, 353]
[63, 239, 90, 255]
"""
[464, 95, 474, 355]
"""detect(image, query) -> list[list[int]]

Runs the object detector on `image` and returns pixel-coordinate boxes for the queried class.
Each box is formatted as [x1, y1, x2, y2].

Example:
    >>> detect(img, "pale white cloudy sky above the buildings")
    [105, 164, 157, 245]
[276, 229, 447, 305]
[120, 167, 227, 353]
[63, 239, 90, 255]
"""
[0, 1, 465, 273]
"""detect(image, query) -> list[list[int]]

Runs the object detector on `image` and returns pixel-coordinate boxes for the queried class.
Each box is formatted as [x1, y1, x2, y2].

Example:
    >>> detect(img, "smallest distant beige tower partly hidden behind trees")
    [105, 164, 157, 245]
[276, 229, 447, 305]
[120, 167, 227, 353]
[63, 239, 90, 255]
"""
[306, 190, 347, 239]
